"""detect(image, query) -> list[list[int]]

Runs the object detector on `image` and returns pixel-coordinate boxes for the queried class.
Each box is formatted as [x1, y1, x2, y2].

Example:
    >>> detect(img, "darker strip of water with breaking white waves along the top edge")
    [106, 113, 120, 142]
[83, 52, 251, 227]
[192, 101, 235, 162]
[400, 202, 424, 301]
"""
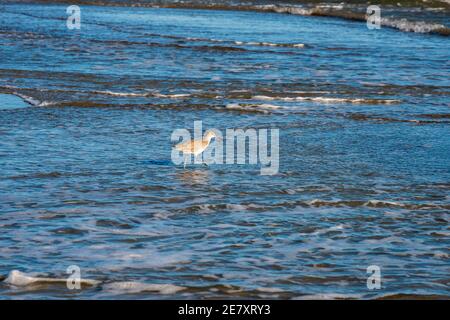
[6, 0, 450, 37]
